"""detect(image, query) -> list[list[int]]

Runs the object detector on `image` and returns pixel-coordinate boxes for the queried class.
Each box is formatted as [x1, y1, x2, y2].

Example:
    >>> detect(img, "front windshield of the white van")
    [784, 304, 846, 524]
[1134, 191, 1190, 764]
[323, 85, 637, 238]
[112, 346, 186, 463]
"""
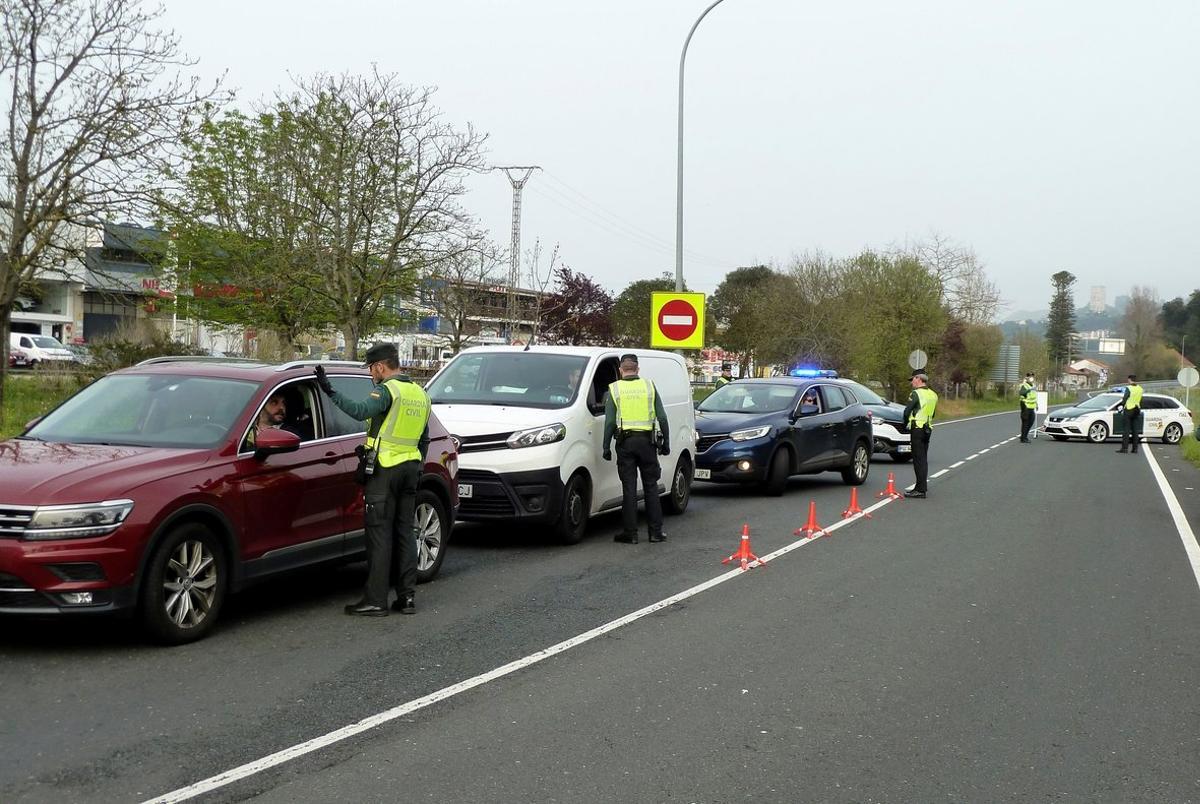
[427, 352, 588, 408]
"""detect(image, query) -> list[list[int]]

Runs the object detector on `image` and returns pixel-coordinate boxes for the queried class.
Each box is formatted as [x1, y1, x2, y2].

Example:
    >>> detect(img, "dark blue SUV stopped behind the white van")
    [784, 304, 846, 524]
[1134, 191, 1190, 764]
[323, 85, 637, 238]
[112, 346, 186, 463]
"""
[694, 377, 871, 497]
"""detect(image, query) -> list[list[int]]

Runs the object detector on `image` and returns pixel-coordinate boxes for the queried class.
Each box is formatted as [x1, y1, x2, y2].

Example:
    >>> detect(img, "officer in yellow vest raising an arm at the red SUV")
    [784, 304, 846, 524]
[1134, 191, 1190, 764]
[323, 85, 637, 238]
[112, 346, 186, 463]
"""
[317, 343, 430, 617]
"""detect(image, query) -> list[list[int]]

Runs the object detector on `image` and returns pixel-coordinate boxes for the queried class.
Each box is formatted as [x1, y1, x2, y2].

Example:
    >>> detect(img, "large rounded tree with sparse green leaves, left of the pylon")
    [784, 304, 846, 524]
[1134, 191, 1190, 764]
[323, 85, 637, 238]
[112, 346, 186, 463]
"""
[168, 72, 485, 359]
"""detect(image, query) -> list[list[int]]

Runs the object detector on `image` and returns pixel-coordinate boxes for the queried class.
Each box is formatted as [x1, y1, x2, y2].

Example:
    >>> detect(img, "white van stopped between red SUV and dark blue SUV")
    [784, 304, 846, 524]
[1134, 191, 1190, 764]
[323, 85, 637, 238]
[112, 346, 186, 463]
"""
[427, 346, 696, 544]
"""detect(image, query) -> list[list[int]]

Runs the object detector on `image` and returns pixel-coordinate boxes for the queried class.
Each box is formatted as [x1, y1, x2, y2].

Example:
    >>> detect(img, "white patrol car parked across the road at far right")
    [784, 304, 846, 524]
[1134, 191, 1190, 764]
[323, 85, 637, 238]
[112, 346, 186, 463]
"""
[1044, 391, 1193, 444]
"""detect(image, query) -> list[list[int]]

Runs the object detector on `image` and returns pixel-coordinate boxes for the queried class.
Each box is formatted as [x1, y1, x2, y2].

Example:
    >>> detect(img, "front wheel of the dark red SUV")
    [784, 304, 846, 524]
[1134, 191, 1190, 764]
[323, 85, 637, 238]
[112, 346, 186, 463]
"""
[139, 522, 229, 644]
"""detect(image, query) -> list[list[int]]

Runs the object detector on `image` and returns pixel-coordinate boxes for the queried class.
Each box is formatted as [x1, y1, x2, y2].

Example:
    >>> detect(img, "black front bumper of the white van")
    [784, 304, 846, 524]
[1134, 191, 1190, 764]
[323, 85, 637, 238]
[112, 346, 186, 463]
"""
[458, 467, 563, 523]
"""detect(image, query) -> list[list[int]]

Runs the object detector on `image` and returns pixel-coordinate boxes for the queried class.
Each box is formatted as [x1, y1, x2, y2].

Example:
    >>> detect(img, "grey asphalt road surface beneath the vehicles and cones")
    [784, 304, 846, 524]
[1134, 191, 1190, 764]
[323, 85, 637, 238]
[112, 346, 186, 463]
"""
[0, 413, 1200, 803]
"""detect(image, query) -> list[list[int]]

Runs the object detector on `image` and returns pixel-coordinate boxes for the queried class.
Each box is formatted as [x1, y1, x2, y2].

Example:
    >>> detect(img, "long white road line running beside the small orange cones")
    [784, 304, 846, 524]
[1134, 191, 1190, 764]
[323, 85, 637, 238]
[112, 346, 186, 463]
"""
[143, 432, 1017, 804]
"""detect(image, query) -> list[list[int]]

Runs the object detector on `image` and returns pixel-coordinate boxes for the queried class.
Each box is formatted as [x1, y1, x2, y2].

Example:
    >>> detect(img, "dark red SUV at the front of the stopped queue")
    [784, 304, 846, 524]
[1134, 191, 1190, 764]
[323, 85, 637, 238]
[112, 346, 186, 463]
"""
[0, 358, 458, 643]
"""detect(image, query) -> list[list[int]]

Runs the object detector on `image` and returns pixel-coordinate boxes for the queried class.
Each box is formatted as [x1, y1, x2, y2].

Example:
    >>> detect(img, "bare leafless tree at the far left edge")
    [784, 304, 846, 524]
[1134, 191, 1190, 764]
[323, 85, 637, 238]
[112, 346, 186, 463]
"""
[0, 0, 216, 415]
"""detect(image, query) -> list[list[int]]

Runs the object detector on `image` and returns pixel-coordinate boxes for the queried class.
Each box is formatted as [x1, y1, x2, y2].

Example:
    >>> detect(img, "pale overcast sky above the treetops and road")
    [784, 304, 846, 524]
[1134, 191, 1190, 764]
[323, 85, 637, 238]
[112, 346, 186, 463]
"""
[166, 0, 1200, 321]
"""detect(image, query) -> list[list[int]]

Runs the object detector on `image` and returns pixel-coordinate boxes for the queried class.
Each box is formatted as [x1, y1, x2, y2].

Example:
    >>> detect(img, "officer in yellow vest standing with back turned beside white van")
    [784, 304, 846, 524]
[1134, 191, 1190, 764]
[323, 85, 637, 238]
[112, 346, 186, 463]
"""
[604, 354, 671, 545]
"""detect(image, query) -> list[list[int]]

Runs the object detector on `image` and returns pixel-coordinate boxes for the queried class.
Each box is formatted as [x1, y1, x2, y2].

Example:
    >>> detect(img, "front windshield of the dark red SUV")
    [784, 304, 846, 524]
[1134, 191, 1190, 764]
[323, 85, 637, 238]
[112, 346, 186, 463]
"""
[25, 374, 258, 448]
